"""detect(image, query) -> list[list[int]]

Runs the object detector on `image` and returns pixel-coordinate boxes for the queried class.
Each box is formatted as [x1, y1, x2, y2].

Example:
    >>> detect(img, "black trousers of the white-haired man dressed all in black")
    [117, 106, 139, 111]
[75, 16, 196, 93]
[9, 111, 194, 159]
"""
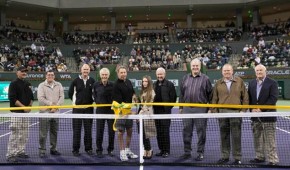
[96, 119, 115, 152]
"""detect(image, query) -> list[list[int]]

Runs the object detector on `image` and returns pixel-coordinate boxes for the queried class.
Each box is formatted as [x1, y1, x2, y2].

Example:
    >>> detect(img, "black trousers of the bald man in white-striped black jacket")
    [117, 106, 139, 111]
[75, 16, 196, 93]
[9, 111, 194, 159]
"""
[73, 108, 93, 151]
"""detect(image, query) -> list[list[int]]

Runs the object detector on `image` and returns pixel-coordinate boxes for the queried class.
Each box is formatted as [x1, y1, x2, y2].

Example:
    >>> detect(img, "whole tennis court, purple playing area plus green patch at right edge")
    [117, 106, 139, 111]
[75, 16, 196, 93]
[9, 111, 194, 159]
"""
[0, 101, 290, 170]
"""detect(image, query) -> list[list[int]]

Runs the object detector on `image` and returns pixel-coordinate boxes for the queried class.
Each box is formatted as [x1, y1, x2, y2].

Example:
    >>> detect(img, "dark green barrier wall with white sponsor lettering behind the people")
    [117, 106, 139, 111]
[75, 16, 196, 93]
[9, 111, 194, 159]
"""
[0, 68, 290, 99]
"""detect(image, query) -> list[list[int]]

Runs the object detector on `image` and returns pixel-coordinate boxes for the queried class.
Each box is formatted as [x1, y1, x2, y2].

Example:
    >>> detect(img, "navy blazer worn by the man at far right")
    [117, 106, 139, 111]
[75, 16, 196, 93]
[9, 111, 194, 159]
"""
[248, 77, 279, 122]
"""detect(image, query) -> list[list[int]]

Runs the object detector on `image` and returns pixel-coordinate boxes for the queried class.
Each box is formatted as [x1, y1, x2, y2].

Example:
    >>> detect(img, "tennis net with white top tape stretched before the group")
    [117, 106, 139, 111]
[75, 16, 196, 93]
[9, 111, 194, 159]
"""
[0, 112, 290, 167]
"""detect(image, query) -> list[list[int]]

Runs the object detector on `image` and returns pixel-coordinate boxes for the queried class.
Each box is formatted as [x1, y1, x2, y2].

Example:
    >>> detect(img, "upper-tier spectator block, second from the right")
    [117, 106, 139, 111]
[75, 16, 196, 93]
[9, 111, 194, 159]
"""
[176, 29, 243, 43]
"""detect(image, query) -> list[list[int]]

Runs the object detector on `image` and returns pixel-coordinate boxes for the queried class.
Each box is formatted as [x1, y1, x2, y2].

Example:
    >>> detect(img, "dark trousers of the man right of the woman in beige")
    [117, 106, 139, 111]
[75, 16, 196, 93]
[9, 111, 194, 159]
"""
[155, 119, 171, 153]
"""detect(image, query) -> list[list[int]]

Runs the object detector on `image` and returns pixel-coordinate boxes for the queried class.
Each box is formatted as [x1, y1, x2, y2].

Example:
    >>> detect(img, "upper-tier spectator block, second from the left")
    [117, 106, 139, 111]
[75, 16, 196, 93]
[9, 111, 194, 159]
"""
[63, 31, 127, 44]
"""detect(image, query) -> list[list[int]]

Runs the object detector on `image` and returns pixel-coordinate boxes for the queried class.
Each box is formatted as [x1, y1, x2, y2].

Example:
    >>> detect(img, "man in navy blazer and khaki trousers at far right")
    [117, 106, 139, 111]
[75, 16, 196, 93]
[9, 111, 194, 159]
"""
[248, 65, 279, 165]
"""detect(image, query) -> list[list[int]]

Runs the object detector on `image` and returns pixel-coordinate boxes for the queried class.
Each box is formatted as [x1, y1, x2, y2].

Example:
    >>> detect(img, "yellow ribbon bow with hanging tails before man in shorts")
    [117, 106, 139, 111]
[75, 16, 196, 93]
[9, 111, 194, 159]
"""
[111, 101, 132, 131]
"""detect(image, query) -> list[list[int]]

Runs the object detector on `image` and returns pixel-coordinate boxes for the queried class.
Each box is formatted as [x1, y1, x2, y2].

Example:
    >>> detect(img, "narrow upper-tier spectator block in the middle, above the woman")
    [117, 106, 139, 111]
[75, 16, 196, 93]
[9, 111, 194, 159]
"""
[133, 33, 169, 44]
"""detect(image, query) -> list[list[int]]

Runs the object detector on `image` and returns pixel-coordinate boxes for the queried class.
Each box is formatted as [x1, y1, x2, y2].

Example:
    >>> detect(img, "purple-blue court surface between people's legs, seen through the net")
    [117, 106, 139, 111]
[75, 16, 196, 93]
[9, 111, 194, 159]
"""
[0, 108, 290, 170]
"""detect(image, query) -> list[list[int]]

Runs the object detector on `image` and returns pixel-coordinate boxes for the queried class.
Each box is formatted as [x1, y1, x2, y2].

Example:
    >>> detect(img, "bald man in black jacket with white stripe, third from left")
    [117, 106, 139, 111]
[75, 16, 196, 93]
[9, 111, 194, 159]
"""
[68, 64, 95, 156]
